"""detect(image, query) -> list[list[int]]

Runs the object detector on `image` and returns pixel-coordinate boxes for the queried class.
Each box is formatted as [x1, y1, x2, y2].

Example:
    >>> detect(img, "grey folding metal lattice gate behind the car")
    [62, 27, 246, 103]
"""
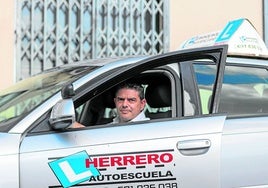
[16, 0, 169, 80]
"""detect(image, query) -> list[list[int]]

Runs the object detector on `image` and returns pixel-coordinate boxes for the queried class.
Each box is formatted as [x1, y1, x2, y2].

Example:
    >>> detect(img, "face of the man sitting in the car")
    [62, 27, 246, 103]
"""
[114, 88, 146, 122]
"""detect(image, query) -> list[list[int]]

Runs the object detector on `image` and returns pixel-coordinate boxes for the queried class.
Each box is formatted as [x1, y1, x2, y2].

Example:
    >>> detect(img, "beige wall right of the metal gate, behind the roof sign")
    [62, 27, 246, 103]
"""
[170, 0, 263, 50]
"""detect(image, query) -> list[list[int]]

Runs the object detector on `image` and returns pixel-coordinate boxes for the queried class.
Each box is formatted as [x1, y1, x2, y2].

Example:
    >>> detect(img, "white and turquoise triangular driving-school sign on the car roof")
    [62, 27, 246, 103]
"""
[180, 18, 268, 57]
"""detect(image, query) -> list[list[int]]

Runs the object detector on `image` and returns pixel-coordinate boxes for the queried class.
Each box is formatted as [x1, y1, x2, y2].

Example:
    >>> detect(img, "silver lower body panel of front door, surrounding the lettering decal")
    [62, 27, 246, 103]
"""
[20, 116, 225, 187]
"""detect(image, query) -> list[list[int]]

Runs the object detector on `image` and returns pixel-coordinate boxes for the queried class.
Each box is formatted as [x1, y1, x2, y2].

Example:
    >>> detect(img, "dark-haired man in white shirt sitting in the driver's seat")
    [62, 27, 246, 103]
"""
[71, 83, 150, 128]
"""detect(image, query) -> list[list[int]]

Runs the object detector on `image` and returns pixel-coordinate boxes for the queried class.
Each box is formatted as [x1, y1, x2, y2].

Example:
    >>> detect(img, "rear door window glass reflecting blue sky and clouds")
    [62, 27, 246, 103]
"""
[219, 66, 268, 114]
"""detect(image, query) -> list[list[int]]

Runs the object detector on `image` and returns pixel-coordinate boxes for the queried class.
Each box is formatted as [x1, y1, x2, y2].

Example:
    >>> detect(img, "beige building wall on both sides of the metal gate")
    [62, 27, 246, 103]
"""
[0, 0, 263, 90]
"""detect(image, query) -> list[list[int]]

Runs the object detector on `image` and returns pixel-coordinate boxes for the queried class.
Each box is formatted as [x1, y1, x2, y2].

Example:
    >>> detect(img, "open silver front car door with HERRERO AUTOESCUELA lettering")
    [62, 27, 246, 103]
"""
[19, 46, 226, 188]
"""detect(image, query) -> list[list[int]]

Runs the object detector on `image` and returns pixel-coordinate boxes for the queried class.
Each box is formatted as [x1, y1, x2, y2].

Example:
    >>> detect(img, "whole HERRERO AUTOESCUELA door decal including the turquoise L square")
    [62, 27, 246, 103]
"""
[50, 149, 178, 188]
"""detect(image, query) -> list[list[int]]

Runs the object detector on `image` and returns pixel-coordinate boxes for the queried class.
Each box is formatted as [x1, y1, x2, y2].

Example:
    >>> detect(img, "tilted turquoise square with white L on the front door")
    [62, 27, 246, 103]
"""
[48, 151, 100, 187]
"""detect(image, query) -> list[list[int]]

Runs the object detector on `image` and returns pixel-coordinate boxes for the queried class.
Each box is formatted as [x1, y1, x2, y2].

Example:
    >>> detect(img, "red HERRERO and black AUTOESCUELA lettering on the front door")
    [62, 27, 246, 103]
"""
[87, 149, 178, 188]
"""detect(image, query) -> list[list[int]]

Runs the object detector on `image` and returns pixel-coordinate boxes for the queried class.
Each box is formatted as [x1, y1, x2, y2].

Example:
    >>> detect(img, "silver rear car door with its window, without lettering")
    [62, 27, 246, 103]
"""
[219, 58, 268, 187]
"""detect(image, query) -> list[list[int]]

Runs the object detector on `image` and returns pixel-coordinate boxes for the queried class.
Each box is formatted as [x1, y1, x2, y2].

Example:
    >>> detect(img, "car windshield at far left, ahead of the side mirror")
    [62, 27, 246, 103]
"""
[0, 66, 97, 128]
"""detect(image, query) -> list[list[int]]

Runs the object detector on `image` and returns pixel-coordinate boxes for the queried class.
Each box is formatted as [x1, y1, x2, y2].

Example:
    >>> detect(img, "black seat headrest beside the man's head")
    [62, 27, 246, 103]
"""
[145, 83, 171, 108]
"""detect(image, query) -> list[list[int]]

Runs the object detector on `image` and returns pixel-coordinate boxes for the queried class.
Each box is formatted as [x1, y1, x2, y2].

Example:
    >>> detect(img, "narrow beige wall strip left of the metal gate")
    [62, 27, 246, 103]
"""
[0, 0, 15, 89]
